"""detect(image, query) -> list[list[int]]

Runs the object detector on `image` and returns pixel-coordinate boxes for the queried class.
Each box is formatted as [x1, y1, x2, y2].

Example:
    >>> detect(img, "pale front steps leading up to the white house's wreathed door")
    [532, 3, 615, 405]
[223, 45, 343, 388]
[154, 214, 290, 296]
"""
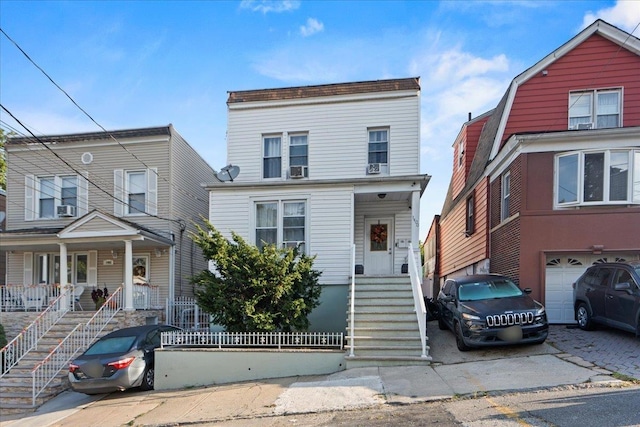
[345, 276, 431, 369]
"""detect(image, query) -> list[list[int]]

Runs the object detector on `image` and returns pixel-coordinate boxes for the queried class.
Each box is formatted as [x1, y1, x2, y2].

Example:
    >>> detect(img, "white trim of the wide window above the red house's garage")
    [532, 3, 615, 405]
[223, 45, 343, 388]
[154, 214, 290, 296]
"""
[553, 148, 640, 210]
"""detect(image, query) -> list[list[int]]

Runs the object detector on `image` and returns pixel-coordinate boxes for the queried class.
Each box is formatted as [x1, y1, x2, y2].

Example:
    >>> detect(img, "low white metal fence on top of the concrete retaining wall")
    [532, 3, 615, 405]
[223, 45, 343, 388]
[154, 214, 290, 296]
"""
[160, 331, 344, 350]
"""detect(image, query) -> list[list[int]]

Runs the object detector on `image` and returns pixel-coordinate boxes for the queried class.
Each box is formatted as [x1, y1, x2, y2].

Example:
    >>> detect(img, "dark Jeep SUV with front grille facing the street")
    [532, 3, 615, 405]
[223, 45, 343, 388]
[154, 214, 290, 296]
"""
[437, 274, 549, 351]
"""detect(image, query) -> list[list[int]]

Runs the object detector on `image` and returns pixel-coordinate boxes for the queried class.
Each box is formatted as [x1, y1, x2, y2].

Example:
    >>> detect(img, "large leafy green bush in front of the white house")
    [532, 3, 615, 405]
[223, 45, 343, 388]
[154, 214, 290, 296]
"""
[192, 220, 321, 332]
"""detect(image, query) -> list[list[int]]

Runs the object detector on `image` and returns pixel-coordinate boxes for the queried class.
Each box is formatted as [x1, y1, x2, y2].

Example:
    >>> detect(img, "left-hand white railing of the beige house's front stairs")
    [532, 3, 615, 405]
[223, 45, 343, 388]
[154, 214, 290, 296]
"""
[0, 289, 71, 378]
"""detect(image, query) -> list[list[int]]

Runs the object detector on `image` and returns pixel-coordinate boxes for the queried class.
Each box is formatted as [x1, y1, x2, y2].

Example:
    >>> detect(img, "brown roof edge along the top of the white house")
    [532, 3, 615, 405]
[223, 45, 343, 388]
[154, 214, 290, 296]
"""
[227, 77, 420, 104]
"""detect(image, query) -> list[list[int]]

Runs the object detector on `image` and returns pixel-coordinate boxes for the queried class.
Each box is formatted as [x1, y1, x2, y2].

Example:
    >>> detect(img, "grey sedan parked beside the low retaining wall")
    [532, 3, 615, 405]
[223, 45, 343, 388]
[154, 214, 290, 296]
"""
[69, 325, 180, 394]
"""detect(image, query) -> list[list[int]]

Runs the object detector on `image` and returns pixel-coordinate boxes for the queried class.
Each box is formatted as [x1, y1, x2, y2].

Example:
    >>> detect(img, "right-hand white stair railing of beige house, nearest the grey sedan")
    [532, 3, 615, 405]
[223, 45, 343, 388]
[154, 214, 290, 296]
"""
[31, 288, 123, 406]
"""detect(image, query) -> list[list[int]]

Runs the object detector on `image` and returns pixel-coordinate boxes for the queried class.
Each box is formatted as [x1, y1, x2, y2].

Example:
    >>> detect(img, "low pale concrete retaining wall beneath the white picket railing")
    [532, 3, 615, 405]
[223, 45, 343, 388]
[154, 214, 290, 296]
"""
[155, 348, 345, 390]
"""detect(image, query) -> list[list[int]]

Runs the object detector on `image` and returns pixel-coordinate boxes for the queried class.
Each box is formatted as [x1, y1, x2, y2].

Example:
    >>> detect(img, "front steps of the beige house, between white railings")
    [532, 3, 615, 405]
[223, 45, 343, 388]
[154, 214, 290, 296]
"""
[0, 311, 116, 415]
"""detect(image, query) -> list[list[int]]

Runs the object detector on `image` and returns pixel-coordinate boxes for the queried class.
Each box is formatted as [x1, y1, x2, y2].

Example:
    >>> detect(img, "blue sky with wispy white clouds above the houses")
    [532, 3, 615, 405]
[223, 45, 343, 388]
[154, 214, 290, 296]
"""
[0, 0, 640, 239]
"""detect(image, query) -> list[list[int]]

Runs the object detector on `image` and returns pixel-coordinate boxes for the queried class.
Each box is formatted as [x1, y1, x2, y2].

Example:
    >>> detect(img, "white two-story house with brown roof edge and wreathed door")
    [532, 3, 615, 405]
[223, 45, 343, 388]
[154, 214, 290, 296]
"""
[205, 78, 430, 338]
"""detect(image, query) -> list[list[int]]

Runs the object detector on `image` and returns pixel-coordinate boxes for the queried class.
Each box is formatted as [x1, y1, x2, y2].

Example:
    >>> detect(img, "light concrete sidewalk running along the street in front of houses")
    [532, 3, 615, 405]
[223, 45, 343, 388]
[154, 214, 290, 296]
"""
[0, 330, 616, 427]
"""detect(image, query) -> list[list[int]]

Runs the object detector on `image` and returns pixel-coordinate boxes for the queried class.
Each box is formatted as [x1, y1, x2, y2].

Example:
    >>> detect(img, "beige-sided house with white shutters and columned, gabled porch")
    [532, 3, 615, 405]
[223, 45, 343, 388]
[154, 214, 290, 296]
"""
[1, 125, 213, 310]
